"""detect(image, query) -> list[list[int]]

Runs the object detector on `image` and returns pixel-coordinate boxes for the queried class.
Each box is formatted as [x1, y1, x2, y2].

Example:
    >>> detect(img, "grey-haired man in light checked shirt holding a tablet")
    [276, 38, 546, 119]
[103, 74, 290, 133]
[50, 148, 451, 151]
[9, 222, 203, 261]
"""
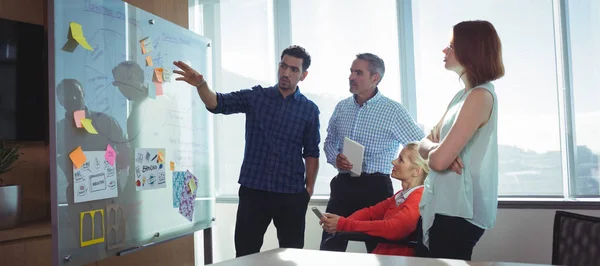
[321, 53, 425, 253]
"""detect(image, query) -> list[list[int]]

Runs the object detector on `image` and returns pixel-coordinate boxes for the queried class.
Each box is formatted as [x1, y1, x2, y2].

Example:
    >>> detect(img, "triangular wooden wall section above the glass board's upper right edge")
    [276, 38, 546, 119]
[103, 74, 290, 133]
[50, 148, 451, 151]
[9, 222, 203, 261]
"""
[124, 0, 188, 29]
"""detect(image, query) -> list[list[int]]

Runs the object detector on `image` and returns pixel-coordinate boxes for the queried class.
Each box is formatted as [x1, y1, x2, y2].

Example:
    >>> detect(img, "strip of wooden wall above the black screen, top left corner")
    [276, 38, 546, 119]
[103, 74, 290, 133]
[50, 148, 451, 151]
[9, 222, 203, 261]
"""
[0, 0, 47, 25]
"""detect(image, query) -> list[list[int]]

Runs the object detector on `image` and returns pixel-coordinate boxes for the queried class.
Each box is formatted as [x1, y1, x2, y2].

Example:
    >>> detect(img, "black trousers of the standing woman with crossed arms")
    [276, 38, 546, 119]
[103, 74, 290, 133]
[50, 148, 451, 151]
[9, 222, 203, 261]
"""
[416, 214, 485, 260]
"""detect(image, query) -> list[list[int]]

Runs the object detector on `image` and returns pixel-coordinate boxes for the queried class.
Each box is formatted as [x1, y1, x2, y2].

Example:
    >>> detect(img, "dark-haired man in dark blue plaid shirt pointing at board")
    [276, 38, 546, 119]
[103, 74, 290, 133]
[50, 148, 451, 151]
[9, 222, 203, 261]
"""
[173, 46, 321, 257]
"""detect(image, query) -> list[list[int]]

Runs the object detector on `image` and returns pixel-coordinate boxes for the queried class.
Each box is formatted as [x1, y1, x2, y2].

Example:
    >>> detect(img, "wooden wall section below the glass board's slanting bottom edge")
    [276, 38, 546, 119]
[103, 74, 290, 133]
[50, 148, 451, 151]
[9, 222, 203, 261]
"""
[95, 235, 195, 266]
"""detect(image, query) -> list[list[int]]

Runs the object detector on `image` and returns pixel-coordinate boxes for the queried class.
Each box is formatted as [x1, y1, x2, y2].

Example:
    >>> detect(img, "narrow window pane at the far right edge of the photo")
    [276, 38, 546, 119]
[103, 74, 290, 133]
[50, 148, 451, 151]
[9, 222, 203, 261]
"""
[568, 0, 600, 196]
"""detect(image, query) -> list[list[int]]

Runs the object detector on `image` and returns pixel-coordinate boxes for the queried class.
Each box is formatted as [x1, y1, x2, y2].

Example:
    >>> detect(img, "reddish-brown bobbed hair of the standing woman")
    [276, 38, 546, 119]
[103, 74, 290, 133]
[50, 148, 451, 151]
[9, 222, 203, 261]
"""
[452, 20, 504, 87]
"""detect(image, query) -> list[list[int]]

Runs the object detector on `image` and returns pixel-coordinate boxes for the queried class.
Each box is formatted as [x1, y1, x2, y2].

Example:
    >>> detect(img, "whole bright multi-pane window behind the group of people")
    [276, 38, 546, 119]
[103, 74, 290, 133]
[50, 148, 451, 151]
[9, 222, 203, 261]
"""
[204, 0, 600, 198]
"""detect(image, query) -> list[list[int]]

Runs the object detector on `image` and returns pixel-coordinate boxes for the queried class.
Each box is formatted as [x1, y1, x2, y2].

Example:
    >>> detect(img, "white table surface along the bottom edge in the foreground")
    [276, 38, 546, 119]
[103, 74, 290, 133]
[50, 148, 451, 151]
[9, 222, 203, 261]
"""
[213, 248, 552, 266]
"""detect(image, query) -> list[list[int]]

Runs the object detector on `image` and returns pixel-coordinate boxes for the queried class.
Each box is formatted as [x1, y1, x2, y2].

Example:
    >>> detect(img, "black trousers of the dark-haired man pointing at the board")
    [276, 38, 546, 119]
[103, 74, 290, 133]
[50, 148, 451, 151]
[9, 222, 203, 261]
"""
[234, 186, 310, 257]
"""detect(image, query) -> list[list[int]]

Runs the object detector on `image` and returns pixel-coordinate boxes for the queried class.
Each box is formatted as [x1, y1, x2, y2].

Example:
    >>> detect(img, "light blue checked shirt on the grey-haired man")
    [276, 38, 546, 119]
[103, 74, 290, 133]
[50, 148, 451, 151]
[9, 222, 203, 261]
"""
[325, 90, 425, 174]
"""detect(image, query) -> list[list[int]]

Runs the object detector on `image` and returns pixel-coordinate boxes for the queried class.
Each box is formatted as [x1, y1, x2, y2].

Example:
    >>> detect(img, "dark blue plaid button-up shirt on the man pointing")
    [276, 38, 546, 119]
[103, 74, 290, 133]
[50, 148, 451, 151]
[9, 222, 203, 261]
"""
[209, 86, 321, 193]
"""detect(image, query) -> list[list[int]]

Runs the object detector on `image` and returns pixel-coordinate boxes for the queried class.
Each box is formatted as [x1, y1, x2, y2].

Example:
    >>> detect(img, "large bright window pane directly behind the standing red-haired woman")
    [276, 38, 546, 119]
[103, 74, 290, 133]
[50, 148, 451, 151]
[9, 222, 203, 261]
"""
[413, 0, 564, 196]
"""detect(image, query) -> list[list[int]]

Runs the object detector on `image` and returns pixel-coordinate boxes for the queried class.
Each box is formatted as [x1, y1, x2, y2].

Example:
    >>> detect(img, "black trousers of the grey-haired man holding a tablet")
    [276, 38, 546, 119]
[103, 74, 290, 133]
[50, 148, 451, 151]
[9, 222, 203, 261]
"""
[320, 173, 394, 253]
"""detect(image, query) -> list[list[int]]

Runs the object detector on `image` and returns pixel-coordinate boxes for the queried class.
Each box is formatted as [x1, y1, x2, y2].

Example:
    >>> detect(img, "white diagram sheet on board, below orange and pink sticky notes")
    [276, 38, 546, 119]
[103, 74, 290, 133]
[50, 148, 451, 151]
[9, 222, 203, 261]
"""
[73, 151, 119, 203]
